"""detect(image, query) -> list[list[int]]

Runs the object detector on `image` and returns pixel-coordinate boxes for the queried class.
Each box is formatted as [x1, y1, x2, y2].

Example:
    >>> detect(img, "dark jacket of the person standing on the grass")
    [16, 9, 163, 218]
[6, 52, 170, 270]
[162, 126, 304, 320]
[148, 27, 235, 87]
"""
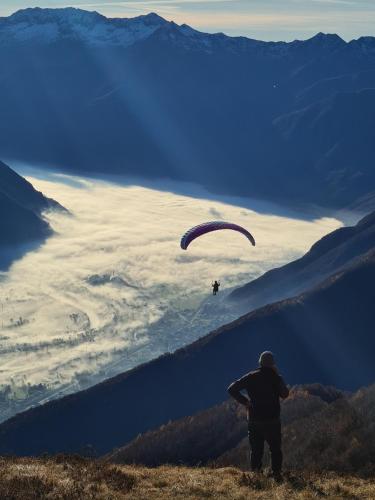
[228, 367, 289, 421]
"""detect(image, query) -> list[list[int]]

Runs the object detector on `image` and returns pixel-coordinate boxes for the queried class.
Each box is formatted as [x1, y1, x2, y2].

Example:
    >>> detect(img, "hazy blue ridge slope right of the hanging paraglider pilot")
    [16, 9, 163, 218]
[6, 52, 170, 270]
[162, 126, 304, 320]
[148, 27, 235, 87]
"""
[229, 212, 375, 311]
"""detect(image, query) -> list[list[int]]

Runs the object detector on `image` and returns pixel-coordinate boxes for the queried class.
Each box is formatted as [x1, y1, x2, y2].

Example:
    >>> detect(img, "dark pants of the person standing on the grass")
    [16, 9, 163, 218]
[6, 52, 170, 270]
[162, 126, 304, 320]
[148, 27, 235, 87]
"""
[249, 419, 283, 474]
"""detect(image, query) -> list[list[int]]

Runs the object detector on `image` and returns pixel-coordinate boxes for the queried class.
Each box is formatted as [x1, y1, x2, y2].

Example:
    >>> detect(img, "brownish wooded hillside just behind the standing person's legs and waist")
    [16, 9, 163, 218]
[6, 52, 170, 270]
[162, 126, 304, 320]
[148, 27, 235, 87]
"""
[108, 385, 375, 475]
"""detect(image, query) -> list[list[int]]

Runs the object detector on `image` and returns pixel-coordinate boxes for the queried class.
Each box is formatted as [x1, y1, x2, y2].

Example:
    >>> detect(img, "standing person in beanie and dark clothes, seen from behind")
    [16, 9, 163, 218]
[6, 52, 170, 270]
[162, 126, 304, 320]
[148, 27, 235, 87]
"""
[228, 351, 289, 481]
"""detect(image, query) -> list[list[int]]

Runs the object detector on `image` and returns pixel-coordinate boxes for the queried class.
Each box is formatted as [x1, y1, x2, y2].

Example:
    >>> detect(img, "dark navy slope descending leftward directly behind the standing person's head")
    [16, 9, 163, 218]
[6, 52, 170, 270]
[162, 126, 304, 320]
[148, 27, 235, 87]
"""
[0, 252, 375, 455]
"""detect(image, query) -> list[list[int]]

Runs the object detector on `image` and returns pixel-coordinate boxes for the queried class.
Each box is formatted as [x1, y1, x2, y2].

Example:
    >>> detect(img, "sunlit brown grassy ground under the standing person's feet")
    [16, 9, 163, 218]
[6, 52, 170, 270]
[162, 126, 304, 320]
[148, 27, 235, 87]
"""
[0, 456, 375, 500]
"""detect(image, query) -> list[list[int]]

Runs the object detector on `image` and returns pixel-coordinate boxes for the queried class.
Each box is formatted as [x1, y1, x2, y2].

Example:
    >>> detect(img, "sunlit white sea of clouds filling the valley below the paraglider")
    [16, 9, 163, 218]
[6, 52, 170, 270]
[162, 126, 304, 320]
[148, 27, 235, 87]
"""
[0, 174, 341, 410]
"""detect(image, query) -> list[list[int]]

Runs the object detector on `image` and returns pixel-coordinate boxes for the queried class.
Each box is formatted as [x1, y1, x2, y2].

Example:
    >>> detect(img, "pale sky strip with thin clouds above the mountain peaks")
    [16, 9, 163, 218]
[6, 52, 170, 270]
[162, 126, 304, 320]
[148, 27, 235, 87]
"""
[0, 0, 375, 41]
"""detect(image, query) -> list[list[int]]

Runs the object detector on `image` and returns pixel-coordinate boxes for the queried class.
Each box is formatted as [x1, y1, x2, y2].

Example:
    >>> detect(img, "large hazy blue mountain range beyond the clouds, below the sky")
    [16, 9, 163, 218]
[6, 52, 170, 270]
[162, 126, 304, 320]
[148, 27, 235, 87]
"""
[0, 8, 375, 209]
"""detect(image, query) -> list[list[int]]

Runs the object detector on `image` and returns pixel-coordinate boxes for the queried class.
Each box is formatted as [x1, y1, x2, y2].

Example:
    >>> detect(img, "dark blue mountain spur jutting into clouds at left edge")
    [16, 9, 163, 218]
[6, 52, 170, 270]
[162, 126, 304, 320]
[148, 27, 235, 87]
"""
[0, 161, 62, 256]
